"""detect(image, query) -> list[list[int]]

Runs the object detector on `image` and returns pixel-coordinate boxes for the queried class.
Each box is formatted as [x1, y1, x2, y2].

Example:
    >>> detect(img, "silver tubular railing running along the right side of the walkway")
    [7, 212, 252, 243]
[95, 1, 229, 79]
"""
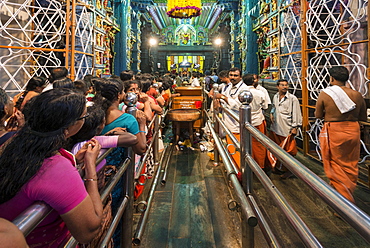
[207, 85, 370, 248]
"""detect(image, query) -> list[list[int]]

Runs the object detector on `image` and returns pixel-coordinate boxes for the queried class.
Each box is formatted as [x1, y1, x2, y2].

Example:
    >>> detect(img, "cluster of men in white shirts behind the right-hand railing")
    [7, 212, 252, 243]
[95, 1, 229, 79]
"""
[210, 68, 302, 179]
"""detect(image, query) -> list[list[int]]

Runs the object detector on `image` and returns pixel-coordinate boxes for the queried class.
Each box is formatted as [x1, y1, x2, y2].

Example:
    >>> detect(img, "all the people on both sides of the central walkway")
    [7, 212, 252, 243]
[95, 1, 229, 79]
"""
[0, 67, 366, 247]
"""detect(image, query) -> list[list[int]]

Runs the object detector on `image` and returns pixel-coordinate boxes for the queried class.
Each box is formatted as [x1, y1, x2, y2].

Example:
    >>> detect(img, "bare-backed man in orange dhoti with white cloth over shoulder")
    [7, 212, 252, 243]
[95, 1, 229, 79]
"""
[315, 66, 366, 203]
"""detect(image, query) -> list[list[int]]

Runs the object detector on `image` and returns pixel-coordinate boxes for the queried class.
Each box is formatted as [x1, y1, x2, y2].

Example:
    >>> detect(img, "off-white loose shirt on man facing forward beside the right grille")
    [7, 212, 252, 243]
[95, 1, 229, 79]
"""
[271, 92, 302, 137]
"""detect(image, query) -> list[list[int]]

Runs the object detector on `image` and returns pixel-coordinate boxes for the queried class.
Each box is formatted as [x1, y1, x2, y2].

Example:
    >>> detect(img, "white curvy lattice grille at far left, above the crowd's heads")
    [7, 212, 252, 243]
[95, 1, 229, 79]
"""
[0, 0, 66, 93]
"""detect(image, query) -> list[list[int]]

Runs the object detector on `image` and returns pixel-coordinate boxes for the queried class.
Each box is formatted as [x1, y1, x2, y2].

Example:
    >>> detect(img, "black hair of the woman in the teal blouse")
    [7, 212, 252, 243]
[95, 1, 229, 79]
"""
[93, 78, 123, 112]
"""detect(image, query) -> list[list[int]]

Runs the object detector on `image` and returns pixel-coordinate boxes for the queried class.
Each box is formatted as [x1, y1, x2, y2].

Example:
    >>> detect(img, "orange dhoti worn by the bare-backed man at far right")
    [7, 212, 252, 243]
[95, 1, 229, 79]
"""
[320, 121, 360, 203]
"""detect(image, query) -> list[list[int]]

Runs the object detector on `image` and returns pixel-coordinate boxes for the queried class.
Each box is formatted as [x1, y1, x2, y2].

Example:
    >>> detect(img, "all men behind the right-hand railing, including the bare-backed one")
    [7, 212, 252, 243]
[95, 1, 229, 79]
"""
[209, 66, 367, 203]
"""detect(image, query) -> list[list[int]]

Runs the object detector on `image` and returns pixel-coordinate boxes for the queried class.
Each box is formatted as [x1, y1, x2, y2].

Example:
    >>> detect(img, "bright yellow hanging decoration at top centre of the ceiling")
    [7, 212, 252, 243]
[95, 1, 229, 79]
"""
[167, 0, 202, 19]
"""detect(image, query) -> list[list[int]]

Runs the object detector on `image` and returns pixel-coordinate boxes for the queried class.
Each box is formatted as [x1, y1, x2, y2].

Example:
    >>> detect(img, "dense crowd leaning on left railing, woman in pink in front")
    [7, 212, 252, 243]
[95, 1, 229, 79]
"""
[0, 67, 178, 247]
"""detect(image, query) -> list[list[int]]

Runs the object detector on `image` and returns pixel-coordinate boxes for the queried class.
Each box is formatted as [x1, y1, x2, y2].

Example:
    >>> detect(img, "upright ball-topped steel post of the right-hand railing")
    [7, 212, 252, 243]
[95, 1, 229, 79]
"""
[238, 90, 254, 248]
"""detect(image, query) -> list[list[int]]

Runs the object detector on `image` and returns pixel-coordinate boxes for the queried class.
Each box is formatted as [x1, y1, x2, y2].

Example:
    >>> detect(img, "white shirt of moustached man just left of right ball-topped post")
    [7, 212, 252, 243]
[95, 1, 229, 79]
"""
[221, 80, 248, 133]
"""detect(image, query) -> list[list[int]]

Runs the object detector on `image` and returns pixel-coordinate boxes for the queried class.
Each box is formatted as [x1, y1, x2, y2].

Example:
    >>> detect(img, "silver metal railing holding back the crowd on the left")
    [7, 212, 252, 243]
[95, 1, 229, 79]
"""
[13, 94, 168, 248]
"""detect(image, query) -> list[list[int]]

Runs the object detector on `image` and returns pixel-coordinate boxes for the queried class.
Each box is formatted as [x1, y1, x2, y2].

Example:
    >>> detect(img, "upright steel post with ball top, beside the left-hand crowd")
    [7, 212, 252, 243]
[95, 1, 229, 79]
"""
[121, 93, 137, 247]
